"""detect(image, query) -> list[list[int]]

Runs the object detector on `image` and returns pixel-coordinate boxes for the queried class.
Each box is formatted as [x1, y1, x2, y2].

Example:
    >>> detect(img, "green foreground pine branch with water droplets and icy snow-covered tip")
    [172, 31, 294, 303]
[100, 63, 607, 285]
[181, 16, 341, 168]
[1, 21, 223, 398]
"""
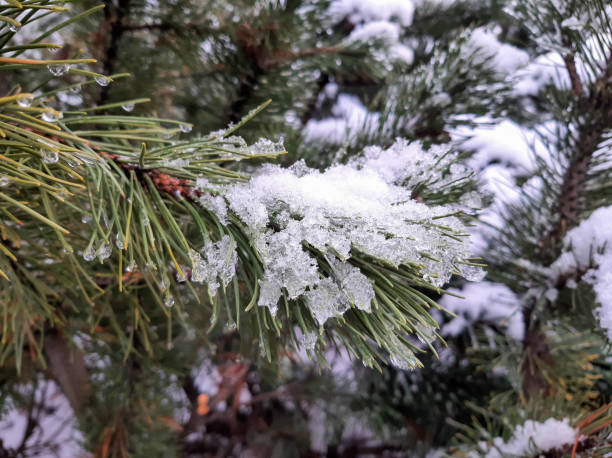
[0, 1, 483, 386]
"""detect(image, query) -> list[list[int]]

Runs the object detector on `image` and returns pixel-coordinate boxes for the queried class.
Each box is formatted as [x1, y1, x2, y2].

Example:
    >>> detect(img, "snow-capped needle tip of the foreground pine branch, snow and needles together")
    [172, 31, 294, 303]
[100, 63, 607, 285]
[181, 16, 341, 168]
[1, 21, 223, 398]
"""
[196, 140, 483, 368]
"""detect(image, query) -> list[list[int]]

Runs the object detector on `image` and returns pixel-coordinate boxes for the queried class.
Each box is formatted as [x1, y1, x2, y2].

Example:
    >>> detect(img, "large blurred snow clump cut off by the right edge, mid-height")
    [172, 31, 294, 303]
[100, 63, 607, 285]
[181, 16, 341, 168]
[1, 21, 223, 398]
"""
[550, 206, 612, 340]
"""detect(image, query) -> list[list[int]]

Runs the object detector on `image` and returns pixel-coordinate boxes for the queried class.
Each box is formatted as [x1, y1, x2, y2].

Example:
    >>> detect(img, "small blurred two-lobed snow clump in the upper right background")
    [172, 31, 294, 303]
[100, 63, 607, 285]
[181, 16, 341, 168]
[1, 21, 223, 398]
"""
[467, 27, 529, 74]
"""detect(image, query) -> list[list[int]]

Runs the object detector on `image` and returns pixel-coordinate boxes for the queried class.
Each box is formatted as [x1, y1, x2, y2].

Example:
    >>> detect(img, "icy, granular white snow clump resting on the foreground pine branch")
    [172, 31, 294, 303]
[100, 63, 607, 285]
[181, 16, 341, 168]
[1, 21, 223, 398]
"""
[225, 140, 483, 324]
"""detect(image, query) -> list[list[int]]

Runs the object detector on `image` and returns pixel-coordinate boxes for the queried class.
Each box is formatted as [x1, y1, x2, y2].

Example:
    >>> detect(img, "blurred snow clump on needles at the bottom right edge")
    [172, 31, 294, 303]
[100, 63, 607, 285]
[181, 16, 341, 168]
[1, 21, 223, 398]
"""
[472, 418, 576, 458]
